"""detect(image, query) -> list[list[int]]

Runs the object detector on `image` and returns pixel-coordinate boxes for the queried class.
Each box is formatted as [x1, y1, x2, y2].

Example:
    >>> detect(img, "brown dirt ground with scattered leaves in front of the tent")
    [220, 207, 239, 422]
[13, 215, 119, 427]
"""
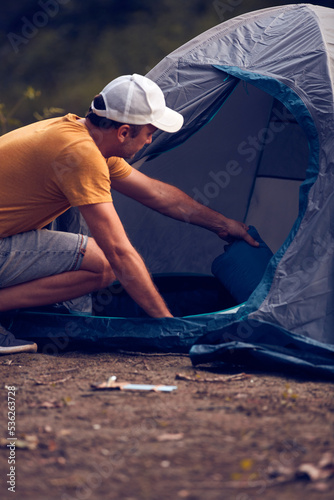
[0, 348, 334, 500]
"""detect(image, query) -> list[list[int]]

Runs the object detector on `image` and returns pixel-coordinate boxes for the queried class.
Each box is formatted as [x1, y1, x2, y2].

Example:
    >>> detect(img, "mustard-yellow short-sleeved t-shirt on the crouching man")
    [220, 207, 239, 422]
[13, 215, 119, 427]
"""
[0, 113, 132, 238]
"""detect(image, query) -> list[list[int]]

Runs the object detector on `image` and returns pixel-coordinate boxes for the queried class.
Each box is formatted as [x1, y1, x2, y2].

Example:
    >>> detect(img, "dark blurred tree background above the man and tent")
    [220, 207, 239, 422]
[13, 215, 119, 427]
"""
[0, 0, 334, 134]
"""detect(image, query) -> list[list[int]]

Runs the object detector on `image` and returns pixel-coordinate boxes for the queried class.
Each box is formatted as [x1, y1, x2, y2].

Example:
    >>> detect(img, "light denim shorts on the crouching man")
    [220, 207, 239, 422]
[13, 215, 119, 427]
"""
[0, 229, 88, 288]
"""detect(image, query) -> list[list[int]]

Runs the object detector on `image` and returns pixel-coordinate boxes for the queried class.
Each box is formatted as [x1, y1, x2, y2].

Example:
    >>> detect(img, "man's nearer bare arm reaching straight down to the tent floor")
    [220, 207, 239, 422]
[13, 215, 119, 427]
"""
[79, 202, 172, 318]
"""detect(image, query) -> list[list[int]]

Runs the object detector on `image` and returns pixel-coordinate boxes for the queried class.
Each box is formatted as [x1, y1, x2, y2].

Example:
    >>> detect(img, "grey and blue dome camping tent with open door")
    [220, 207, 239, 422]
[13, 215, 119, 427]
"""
[7, 4, 334, 373]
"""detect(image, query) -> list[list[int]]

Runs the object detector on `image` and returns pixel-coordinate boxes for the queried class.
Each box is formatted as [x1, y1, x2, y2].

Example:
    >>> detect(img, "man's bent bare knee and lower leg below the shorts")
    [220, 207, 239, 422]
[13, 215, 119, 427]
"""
[0, 238, 116, 311]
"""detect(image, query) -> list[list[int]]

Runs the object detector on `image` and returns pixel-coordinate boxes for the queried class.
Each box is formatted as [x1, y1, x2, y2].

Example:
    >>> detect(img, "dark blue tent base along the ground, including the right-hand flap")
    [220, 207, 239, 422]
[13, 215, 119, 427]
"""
[6, 294, 334, 379]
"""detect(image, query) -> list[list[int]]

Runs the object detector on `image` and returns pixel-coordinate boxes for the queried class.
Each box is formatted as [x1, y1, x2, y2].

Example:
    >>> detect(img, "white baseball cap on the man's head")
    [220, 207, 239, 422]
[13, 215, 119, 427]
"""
[91, 74, 183, 132]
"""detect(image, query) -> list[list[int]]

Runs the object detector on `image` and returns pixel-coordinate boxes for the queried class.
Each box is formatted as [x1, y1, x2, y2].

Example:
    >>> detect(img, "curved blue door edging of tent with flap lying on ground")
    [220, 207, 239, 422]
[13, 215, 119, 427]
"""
[189, 66, 334, 378]
